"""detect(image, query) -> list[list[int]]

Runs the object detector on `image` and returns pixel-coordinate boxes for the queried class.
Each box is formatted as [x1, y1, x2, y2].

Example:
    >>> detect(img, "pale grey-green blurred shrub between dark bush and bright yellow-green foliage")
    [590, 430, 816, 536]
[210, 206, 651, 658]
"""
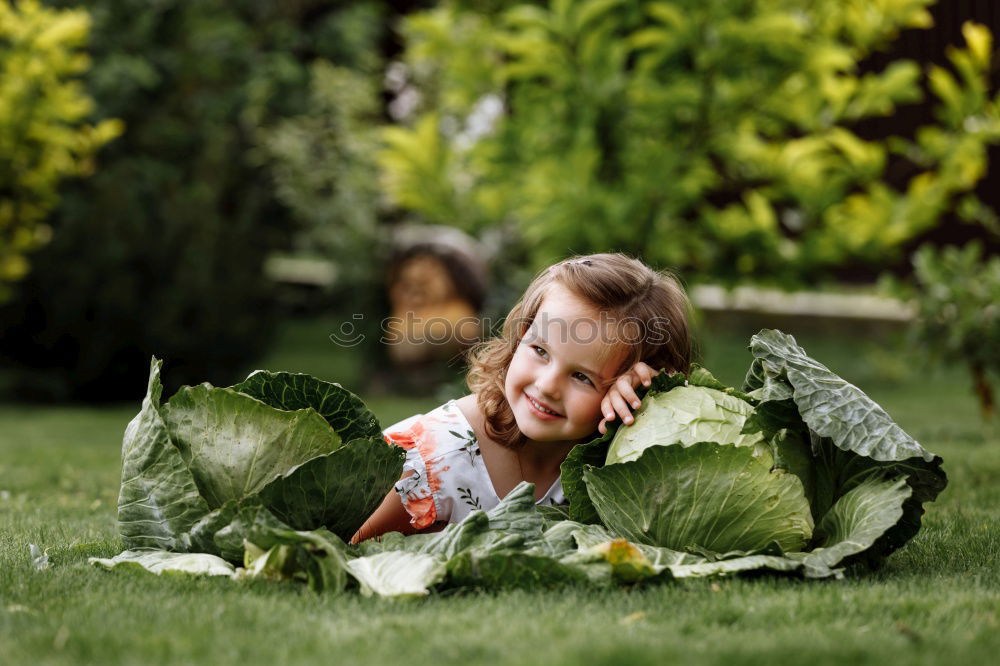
[260, 61, 391, 378]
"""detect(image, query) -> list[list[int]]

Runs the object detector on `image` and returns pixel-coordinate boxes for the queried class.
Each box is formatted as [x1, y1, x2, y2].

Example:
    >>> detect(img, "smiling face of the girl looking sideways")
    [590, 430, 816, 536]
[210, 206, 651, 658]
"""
[504, 283, 626, 442]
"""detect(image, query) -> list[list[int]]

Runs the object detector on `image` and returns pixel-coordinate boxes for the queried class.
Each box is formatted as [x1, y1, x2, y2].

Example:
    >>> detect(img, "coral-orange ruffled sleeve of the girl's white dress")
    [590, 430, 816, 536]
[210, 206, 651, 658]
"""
[385, 419, 440, 530]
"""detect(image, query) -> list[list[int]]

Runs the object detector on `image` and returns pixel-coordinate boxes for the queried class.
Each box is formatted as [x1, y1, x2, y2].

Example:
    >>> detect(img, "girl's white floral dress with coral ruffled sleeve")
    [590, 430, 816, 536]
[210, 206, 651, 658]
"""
[383, 400, 566, 529]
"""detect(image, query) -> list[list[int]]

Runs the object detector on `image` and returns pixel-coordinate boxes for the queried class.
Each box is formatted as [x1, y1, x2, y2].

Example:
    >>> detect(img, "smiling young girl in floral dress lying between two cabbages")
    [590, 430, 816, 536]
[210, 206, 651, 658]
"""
[352, 254, 691, 543]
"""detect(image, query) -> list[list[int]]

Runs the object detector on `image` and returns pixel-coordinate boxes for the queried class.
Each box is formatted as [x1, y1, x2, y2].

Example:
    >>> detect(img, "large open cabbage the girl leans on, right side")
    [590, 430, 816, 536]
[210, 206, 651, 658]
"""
[563, 330, 946, 576]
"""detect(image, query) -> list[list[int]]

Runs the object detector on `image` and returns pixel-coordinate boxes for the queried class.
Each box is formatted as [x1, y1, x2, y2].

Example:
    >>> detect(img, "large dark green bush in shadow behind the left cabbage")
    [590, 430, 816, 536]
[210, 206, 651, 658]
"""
[0, 0, 382, 399]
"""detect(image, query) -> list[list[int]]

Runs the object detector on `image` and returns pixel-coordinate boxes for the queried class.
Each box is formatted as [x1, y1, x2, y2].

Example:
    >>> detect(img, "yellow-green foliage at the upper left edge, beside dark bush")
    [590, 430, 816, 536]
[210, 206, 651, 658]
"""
[0, 0, 122, 301]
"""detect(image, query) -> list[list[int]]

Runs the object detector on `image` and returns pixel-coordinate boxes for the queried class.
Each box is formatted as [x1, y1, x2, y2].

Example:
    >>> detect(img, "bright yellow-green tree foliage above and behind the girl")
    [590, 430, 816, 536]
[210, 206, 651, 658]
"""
[380, 0, 1000, 283]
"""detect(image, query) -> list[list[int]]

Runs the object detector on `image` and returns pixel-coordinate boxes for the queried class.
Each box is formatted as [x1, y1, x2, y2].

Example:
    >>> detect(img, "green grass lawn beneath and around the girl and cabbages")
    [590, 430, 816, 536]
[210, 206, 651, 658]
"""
[0, 322, 1000, 666]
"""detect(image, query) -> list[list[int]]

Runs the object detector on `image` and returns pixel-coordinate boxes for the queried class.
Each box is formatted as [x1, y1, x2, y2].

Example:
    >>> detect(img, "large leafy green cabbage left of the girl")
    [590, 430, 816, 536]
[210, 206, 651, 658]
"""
[118, 358, 404, 561]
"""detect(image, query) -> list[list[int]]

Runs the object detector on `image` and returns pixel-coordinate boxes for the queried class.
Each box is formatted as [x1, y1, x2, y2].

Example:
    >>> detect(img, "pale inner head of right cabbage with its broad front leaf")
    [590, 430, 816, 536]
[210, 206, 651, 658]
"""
[600, 385, 813, 553]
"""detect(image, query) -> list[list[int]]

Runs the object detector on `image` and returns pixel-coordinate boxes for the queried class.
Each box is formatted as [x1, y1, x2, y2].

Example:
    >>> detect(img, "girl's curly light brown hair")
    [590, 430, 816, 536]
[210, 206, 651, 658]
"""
[466, 253, 691, 448]
